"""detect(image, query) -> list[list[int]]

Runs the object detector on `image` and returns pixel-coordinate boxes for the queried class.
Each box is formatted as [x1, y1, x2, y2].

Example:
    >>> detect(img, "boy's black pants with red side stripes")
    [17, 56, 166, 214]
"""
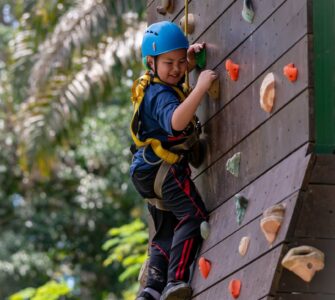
[132, 161, 207, 292]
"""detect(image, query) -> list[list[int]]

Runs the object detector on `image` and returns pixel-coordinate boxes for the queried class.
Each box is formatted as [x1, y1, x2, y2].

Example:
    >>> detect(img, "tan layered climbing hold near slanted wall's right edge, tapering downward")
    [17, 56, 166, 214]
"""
[261, 204, 285, 244]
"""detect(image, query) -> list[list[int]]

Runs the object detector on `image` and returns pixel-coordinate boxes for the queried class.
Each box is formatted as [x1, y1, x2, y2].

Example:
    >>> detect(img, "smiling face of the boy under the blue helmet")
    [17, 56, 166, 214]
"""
[148, 49, 187, 85]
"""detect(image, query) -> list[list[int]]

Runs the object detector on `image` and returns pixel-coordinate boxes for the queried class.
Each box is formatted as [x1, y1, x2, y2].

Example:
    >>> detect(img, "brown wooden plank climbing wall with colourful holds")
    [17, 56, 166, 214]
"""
[147, 0, 335, 300]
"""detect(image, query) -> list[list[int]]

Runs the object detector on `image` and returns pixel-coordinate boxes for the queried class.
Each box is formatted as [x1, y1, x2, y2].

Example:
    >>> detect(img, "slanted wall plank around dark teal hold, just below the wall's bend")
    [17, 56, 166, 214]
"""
[201, 147, 311, 252]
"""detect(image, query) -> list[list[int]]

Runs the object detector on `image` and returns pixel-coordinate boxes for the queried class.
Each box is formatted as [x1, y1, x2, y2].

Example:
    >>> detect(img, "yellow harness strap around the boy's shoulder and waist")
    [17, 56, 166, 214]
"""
[130, 72, 189, 164]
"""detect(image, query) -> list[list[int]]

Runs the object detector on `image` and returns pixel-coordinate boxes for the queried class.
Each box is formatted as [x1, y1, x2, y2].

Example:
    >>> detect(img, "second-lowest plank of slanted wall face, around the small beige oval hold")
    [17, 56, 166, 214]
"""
[192, 193, 298, 294]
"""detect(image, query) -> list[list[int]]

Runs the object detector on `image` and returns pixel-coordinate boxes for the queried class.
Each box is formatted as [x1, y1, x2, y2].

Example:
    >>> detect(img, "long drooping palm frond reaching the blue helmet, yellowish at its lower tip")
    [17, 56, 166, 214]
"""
[16, 23, 145, 175]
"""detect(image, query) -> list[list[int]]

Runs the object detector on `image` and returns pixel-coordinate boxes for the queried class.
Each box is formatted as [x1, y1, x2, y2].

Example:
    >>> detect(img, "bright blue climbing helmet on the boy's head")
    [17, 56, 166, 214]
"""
[142, 21, 189, 57]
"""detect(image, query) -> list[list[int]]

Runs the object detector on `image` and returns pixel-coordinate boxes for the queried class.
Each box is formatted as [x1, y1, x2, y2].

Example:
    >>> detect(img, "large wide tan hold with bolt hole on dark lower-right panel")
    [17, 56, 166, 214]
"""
[282, 246, 325, 282]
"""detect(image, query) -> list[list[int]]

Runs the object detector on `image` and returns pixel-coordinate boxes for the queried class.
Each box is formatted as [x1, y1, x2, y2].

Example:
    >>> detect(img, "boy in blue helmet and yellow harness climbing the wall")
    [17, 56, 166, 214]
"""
[130, 21, 217, 300]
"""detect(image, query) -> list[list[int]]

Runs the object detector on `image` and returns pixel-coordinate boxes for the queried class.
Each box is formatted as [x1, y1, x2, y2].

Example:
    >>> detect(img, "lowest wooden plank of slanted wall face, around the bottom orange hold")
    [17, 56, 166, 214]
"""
[194, 246, 282, 300]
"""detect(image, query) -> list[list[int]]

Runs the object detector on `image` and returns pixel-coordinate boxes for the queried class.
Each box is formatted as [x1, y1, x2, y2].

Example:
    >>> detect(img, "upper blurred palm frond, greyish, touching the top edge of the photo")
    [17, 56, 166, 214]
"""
[30, 0, 108, 94]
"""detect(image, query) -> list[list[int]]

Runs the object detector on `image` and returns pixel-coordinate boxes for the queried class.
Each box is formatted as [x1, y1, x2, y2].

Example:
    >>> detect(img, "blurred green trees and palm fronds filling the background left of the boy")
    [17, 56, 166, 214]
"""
[0, 0, 147, 300]
